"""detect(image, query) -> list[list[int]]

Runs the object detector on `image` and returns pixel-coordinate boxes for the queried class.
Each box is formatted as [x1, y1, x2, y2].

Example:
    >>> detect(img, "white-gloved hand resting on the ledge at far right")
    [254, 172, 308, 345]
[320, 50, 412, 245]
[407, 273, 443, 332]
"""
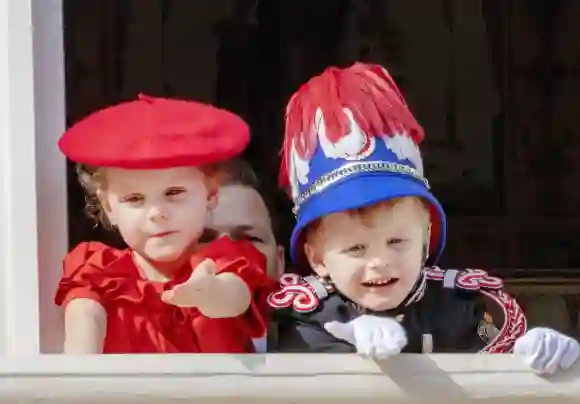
[514, 327, 580, 375]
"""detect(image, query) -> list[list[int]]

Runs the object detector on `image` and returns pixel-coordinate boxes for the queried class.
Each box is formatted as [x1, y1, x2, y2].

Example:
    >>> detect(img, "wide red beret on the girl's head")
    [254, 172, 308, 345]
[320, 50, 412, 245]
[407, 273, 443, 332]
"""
[58, 95, 250, 169]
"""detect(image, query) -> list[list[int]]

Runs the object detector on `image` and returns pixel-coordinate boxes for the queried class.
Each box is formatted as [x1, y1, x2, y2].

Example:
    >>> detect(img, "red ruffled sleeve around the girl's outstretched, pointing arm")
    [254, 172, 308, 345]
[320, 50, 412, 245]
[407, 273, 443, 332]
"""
[191, 236, 278, 338]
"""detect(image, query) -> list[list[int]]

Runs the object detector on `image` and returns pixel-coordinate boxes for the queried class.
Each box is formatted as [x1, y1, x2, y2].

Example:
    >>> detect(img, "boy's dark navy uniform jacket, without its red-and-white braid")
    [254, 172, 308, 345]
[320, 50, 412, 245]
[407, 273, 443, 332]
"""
[272, 274, 497, 353]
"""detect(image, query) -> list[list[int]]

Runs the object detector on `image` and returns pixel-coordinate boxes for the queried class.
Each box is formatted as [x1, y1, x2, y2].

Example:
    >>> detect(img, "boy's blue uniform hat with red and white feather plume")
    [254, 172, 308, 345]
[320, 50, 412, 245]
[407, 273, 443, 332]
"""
[280, 63, 446, 262]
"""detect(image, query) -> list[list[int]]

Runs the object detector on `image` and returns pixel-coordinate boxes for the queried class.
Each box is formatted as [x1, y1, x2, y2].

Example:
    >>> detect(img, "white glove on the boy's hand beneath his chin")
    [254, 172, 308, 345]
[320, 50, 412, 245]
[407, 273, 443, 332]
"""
[324, 315, 407, 359]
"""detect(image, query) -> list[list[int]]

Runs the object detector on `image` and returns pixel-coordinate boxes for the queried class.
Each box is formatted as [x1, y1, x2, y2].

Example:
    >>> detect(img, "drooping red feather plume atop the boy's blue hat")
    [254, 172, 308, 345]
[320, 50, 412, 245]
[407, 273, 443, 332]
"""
[279, 63, 424, 188]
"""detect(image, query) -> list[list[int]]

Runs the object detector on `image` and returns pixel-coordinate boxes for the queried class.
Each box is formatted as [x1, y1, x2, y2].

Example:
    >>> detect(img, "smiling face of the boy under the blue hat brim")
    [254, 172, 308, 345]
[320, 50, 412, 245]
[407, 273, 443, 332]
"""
[305, 198, 429, 311]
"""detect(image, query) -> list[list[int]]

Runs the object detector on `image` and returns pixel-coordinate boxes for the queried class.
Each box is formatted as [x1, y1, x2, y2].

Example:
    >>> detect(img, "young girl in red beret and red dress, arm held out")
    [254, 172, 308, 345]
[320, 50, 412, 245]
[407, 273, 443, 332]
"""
[55, 96, 270, 354]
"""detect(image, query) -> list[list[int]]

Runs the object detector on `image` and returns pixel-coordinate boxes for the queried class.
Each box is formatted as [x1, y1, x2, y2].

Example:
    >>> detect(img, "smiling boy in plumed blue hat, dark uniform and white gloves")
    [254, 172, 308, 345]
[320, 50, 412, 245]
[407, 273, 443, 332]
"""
[269, 63, 580, 374]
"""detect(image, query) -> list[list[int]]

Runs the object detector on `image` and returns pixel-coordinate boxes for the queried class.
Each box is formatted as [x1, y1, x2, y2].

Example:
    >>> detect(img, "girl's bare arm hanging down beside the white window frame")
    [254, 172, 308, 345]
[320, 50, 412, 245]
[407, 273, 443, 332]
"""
[64, 298, 107, 355]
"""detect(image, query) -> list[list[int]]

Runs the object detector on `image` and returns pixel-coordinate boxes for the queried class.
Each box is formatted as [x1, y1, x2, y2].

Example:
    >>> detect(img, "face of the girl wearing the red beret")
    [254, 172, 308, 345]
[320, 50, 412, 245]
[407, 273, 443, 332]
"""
[100, 167, 216, 263]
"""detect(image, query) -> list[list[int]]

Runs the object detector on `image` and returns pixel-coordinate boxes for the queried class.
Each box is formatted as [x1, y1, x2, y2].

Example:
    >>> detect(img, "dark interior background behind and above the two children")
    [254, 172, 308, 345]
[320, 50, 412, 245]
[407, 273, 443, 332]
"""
[64, 0, 580, 334]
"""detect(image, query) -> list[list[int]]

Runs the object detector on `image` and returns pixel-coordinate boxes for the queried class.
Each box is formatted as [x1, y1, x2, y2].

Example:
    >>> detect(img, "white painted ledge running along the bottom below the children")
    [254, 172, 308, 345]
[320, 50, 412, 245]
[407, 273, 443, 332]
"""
[0, 354, 580, 404]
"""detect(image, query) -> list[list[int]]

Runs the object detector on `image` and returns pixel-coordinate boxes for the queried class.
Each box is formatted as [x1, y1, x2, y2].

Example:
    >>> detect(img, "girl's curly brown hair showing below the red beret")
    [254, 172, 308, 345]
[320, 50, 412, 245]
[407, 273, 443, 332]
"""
[75, 164, 221, 230]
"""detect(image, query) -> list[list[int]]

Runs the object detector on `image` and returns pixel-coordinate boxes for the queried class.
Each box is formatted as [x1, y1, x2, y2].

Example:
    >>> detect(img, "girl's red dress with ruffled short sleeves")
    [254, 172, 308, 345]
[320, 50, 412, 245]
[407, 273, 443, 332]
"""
[55, 237, 277, 353]
